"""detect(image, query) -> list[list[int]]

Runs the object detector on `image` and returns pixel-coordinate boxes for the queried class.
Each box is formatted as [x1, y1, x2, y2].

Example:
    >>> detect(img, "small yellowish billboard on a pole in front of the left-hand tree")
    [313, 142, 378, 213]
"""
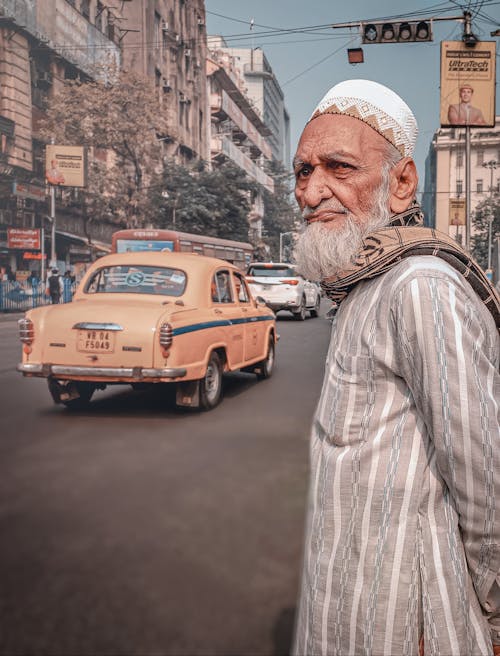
[45, 144, 87, 187]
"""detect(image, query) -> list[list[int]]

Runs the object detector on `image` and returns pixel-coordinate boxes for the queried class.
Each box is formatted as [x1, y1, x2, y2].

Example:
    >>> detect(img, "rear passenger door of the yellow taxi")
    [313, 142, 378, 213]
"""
[211, 269, 245, 369]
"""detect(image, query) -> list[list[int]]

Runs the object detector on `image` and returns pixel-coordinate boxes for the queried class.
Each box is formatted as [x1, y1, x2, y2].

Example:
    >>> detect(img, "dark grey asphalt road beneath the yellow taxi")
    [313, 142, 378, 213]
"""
[0, 308, 330, 656]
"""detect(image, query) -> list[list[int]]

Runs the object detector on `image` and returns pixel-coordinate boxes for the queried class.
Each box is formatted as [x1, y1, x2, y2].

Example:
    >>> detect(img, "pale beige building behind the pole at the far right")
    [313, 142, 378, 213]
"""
[422, 116, 500, 244]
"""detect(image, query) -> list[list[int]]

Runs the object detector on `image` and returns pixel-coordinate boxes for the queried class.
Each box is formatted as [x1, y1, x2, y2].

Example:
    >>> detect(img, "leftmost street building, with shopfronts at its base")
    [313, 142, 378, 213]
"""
[0, 0, 122, 280]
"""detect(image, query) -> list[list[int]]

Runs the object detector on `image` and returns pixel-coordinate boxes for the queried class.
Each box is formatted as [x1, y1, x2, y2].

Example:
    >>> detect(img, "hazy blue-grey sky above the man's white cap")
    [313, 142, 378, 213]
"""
[205, 0, 500, 190]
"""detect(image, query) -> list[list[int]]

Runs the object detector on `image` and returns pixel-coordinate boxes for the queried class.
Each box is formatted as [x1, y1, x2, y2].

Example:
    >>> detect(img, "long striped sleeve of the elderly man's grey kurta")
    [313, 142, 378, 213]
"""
[392, 271, 500, 644]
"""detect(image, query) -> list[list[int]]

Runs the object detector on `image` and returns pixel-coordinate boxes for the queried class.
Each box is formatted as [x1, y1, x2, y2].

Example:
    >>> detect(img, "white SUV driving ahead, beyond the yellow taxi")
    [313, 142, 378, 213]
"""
[246, 262, 321, 321]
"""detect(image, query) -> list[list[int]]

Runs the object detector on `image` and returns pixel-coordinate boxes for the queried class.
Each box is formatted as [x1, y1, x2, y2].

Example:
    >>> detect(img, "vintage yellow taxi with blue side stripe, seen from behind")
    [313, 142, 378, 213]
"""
[18, 252, 278, 410]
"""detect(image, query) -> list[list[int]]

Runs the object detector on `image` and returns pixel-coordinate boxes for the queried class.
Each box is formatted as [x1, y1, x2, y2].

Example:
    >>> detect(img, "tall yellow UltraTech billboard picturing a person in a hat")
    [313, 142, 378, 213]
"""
[440, 41, 496, 127]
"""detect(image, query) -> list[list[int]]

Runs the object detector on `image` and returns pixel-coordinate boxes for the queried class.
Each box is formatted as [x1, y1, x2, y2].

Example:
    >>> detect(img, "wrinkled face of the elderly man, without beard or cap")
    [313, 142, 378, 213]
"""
[294, 114, 394, 229]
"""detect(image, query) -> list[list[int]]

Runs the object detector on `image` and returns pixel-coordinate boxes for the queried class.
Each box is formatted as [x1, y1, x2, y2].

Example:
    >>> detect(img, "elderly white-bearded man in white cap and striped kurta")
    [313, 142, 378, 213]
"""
[294, 80, 500, 656]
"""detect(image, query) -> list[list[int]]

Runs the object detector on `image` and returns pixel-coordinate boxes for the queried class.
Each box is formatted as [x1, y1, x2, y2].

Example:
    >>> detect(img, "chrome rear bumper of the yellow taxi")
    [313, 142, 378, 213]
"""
[17, 362, 187, 382]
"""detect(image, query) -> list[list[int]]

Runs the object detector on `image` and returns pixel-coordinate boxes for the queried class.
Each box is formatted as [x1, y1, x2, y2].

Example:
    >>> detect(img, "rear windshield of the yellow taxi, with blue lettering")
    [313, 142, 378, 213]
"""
[85, 264, 186, 296]
